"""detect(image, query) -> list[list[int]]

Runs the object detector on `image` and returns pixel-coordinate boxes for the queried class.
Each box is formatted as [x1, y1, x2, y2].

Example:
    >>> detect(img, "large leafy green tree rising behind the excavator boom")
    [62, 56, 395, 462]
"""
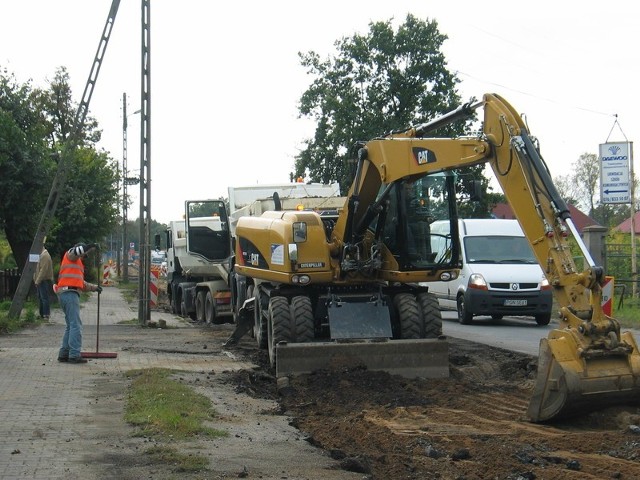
[291, 14, 488, 195]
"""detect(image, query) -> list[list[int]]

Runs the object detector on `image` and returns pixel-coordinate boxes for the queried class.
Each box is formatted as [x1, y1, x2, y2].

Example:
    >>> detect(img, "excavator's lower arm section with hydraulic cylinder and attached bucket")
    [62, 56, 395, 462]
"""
[483, 94, 640, 421]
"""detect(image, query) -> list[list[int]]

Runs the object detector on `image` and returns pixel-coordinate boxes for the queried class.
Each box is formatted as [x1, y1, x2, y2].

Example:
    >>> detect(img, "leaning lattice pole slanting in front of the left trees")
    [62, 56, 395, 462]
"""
[8, 0, 120, 318]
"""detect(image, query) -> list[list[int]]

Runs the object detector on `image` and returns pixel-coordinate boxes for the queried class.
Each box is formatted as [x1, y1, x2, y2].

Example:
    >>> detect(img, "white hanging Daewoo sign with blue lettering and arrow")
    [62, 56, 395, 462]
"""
[600, 143, 631, 203]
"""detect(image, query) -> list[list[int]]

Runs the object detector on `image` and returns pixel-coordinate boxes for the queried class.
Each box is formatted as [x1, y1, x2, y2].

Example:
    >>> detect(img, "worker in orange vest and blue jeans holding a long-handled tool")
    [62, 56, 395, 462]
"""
[53, 243, 102, 363]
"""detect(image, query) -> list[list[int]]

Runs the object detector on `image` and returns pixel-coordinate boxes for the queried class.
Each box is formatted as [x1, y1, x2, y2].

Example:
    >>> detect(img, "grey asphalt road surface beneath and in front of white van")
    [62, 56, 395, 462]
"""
[442, 311, 640, 356]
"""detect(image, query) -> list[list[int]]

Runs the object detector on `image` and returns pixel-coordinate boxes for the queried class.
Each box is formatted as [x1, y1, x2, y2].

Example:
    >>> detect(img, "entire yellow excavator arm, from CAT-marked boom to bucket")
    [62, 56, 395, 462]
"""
[332, 94, 640, 422]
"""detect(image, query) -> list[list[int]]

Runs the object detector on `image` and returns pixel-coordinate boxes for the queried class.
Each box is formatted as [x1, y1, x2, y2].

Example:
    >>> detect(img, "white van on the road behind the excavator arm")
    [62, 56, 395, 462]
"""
[428, 219, 553, 325]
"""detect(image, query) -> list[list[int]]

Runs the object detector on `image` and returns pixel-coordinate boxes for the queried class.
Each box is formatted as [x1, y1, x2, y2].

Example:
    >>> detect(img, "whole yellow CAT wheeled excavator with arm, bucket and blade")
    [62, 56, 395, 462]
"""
[232, 94, 640, 422]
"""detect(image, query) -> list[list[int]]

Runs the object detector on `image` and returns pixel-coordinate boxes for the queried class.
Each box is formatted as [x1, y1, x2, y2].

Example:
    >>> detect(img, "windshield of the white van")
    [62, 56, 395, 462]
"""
[464, 235, 538, 264]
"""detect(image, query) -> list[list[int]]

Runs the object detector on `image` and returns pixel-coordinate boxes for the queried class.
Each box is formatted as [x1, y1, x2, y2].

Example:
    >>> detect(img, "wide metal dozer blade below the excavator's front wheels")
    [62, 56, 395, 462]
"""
[276, 337, 449, 378]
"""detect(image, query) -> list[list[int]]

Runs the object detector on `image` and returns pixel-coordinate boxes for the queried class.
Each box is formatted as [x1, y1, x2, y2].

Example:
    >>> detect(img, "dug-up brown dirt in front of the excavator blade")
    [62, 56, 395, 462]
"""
[229, 340, 640, 480]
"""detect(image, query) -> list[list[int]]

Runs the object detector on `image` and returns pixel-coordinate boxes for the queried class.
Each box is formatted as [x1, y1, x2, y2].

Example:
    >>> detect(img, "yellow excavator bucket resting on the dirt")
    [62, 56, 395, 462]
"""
[528, 329, 640, 422]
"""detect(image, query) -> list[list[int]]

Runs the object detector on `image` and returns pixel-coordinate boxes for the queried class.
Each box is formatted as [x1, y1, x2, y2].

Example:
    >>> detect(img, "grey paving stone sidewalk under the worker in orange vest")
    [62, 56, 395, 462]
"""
[0, 287, 201, 480]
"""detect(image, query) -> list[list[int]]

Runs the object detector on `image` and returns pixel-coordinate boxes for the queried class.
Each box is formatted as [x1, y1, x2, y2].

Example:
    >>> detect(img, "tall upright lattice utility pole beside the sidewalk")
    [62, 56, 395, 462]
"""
[138, 0, 151, 325]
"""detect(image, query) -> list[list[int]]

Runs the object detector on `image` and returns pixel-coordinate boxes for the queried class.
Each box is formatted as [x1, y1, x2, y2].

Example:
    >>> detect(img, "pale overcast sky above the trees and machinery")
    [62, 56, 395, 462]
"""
[0, 0, 640, 222]
